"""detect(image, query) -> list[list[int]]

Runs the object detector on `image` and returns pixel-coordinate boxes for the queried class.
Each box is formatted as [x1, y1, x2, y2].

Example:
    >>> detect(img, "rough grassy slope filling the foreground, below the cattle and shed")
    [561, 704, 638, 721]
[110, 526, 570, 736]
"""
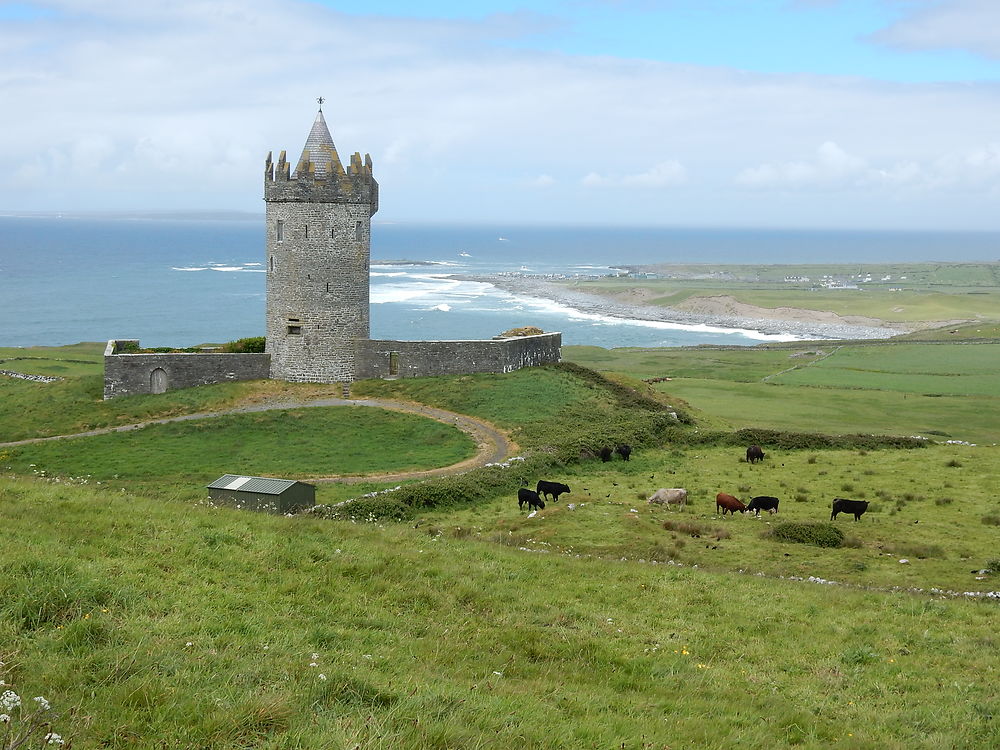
[0, 478, 1000, 750]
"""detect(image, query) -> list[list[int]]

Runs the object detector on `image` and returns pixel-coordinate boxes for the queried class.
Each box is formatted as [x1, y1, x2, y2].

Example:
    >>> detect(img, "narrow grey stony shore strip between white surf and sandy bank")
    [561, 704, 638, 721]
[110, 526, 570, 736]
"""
[458, 274, 908, 340]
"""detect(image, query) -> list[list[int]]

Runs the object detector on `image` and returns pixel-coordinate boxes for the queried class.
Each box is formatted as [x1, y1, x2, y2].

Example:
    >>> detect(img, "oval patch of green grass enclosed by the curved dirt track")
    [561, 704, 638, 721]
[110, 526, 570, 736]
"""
[0, 406, 476, 482]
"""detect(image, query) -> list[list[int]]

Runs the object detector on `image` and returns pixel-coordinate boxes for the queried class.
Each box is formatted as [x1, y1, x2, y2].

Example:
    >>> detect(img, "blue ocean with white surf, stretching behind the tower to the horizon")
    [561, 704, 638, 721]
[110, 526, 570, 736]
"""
[0, 216, 1000, 347]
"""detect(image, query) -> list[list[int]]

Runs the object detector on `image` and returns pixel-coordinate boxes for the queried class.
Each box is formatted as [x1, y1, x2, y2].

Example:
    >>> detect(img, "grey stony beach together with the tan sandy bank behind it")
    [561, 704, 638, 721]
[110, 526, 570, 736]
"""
[461, 275, 909, 339]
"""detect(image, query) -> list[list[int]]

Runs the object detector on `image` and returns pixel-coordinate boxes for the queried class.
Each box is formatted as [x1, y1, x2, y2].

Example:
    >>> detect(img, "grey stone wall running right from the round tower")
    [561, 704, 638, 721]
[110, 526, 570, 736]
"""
[357, 333, 562, 378]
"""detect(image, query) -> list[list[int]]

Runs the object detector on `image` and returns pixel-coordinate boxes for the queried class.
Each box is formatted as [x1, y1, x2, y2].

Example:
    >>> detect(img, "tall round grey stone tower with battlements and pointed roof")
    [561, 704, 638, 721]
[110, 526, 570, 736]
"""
[264, 102, 378, 383]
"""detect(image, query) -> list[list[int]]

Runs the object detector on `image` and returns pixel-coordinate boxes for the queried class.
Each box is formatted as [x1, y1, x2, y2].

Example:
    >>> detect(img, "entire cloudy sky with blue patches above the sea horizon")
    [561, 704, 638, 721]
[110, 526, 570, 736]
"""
[0, 0, 1000, 231]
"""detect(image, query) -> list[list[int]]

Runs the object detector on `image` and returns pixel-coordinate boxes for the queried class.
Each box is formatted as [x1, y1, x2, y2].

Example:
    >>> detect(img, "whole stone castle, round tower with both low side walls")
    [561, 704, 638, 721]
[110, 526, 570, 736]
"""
[104, 107, 562, 399]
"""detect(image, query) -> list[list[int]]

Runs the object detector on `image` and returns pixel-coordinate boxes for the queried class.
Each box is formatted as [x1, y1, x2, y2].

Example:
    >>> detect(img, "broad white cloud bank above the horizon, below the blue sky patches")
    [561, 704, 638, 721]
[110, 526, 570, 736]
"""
[0, 0, 1000, 228]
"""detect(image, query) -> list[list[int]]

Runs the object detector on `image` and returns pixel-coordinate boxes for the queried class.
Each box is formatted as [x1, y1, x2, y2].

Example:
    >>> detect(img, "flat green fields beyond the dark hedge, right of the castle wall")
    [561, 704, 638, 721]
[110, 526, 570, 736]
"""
[563, 341, 1000, 443]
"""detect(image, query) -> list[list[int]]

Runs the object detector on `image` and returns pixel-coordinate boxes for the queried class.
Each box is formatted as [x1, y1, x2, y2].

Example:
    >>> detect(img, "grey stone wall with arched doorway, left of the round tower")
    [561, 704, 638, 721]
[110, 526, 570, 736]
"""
[104, 339, 271, 400]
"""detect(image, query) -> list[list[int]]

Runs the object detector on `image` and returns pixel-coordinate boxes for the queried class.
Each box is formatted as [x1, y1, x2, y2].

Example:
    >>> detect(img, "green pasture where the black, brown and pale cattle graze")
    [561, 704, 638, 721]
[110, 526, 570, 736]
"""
[420, 445, 1000, 591]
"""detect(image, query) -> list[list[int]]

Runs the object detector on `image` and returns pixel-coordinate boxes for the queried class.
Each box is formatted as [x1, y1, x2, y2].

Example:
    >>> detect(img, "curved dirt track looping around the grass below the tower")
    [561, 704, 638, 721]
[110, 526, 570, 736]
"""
[0, 398, 516, 483]
